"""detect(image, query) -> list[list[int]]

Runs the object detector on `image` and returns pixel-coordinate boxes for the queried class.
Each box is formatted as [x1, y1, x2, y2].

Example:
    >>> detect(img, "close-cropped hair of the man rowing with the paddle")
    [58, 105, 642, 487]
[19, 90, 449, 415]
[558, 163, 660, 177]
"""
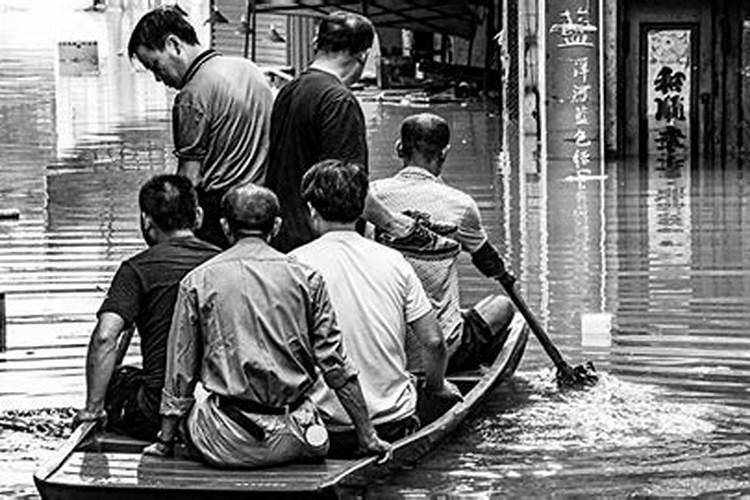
[401, 113, 451, 161]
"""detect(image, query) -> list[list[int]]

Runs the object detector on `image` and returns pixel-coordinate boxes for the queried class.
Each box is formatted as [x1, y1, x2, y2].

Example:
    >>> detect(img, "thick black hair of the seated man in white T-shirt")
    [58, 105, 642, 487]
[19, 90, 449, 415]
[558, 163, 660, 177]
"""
[300, 160, 368, 223]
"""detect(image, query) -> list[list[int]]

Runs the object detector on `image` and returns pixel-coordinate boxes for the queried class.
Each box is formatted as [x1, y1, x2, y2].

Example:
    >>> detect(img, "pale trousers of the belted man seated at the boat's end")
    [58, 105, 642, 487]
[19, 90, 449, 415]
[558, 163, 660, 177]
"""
[187, 395, 329, 468]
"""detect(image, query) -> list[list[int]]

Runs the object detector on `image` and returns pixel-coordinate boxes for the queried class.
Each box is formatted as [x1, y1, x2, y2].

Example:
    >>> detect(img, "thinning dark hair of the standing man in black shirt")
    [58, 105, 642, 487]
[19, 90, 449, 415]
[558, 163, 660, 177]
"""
[315, 11, 375, 54]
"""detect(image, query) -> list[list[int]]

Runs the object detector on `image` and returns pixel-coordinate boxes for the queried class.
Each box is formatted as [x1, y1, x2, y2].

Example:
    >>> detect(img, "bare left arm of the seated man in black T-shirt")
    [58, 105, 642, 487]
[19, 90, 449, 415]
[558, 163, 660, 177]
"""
[84, 312, 125, 420]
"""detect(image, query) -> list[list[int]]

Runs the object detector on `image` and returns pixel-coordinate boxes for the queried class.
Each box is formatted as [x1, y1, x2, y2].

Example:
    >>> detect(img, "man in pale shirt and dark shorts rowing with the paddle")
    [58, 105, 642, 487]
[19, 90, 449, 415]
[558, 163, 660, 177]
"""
[372, 113, 525, 372]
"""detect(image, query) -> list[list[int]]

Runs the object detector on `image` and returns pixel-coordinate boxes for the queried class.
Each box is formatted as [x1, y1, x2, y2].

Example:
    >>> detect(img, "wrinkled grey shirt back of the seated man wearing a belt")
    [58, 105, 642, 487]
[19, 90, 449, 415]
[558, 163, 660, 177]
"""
[172, 238, 344, 406]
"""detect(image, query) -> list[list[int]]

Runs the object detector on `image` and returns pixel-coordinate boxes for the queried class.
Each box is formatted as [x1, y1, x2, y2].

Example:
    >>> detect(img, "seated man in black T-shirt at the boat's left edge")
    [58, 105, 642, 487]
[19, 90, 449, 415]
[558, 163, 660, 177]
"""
[74, 175, 219, 440]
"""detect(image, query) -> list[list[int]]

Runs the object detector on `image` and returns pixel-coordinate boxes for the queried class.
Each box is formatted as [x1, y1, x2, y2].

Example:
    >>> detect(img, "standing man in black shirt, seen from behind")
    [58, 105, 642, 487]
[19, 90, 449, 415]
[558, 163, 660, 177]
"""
[266, 12, 458, 257]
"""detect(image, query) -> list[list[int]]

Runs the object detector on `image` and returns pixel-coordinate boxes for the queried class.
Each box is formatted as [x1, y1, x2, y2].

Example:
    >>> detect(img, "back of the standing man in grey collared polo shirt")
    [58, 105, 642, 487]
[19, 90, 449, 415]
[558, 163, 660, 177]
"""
[175, 51, 273, 191]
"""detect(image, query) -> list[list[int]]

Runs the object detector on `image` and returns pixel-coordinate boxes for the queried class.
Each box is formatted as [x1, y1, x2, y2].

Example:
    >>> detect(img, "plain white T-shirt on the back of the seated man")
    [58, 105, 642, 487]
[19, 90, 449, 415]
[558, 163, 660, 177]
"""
[292, 231, 431, 429]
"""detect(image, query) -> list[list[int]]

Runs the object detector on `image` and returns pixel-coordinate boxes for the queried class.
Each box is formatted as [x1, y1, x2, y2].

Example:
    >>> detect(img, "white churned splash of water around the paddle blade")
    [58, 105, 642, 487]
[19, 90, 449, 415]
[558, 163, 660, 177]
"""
[490, 371, 720, 452]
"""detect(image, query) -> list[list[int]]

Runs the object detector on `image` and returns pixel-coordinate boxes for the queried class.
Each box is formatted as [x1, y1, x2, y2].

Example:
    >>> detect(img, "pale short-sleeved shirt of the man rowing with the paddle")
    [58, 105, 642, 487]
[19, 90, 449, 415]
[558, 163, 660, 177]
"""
[371, 167, 487, 352]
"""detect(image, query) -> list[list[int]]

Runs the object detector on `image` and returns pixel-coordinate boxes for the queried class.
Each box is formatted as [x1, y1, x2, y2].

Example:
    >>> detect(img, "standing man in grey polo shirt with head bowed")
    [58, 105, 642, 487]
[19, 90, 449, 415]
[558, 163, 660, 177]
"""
[128, 7, 273, 248]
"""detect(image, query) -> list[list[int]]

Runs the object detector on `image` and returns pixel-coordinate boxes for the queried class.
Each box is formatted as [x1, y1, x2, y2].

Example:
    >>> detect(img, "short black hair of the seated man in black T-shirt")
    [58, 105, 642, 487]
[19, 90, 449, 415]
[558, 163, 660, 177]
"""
[138, 174, 198, 231]
